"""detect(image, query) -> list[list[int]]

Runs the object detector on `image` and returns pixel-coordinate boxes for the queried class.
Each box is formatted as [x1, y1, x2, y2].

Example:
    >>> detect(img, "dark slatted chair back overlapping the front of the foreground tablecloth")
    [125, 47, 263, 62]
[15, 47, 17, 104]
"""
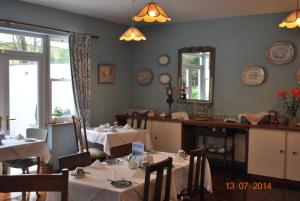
[143, 157, 172, 201]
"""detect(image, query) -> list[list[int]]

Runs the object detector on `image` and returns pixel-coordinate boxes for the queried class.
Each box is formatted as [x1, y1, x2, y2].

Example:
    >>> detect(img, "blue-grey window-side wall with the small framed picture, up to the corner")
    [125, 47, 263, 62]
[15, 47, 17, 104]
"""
[0, 0, 132, 125]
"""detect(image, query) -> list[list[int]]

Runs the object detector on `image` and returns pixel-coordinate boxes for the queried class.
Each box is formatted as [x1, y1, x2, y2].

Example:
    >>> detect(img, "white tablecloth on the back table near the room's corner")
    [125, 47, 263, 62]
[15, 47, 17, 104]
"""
[86, 128, 153, 154]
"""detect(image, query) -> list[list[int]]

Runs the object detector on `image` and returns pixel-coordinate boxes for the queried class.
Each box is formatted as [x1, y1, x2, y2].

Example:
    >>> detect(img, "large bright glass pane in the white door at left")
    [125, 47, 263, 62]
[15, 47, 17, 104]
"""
[9, 60, 39, 136]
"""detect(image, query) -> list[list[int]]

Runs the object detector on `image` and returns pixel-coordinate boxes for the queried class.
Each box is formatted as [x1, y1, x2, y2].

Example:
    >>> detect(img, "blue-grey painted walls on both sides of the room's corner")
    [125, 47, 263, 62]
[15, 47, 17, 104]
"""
[0, 0, 300, 119]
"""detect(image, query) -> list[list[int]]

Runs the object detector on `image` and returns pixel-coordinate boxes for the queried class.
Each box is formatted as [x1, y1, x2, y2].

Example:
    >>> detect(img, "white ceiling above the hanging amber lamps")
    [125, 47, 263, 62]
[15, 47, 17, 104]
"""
[21, 0, 296, 24]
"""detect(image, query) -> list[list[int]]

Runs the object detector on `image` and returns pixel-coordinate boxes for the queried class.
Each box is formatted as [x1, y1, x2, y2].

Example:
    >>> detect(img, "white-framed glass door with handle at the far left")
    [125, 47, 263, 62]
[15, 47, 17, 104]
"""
[0, 54, 42, 136]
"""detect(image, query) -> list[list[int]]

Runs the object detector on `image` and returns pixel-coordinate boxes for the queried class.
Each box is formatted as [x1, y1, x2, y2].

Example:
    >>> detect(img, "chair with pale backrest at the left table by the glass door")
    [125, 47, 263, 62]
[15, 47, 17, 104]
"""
[3, 128, 48, 174]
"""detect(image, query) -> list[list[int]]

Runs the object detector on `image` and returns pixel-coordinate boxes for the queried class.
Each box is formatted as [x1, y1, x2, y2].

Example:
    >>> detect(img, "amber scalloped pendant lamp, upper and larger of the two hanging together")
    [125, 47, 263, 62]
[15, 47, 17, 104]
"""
[133, 0, 171, 23]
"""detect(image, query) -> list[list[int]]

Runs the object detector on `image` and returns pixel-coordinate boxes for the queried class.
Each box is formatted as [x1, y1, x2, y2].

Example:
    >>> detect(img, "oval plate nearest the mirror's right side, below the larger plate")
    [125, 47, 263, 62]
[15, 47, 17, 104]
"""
[241, 66, 265, 85]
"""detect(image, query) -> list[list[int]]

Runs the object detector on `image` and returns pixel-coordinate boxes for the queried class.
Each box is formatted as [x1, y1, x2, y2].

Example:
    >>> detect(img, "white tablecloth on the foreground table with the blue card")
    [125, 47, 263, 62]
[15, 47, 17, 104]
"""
[46, 152, 212, 201]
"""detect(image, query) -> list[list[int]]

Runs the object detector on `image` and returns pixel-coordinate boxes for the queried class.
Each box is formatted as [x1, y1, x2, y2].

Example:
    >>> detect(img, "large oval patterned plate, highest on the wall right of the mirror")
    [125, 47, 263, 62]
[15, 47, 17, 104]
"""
[266, 42, 295, 64]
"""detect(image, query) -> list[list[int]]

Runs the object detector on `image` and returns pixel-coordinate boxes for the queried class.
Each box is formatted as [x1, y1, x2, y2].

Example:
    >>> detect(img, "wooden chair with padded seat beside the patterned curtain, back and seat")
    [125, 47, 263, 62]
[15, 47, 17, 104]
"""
[72, 116, 107, 161]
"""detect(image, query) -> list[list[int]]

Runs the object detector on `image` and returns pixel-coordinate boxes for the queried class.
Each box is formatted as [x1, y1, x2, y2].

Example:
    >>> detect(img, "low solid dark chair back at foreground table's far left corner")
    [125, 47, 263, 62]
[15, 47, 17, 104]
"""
[58, 152, 92, 171]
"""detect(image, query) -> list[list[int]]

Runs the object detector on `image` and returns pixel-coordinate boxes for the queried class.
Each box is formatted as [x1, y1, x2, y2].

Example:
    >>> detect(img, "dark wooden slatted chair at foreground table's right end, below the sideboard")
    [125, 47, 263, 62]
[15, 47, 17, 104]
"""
[181, 147, 206, 201]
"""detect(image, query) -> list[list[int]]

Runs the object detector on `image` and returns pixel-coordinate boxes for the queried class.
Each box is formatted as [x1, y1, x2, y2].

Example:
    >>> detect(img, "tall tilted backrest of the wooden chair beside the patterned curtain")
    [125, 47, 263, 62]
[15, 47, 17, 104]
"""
[72, 116, 89, 152]
